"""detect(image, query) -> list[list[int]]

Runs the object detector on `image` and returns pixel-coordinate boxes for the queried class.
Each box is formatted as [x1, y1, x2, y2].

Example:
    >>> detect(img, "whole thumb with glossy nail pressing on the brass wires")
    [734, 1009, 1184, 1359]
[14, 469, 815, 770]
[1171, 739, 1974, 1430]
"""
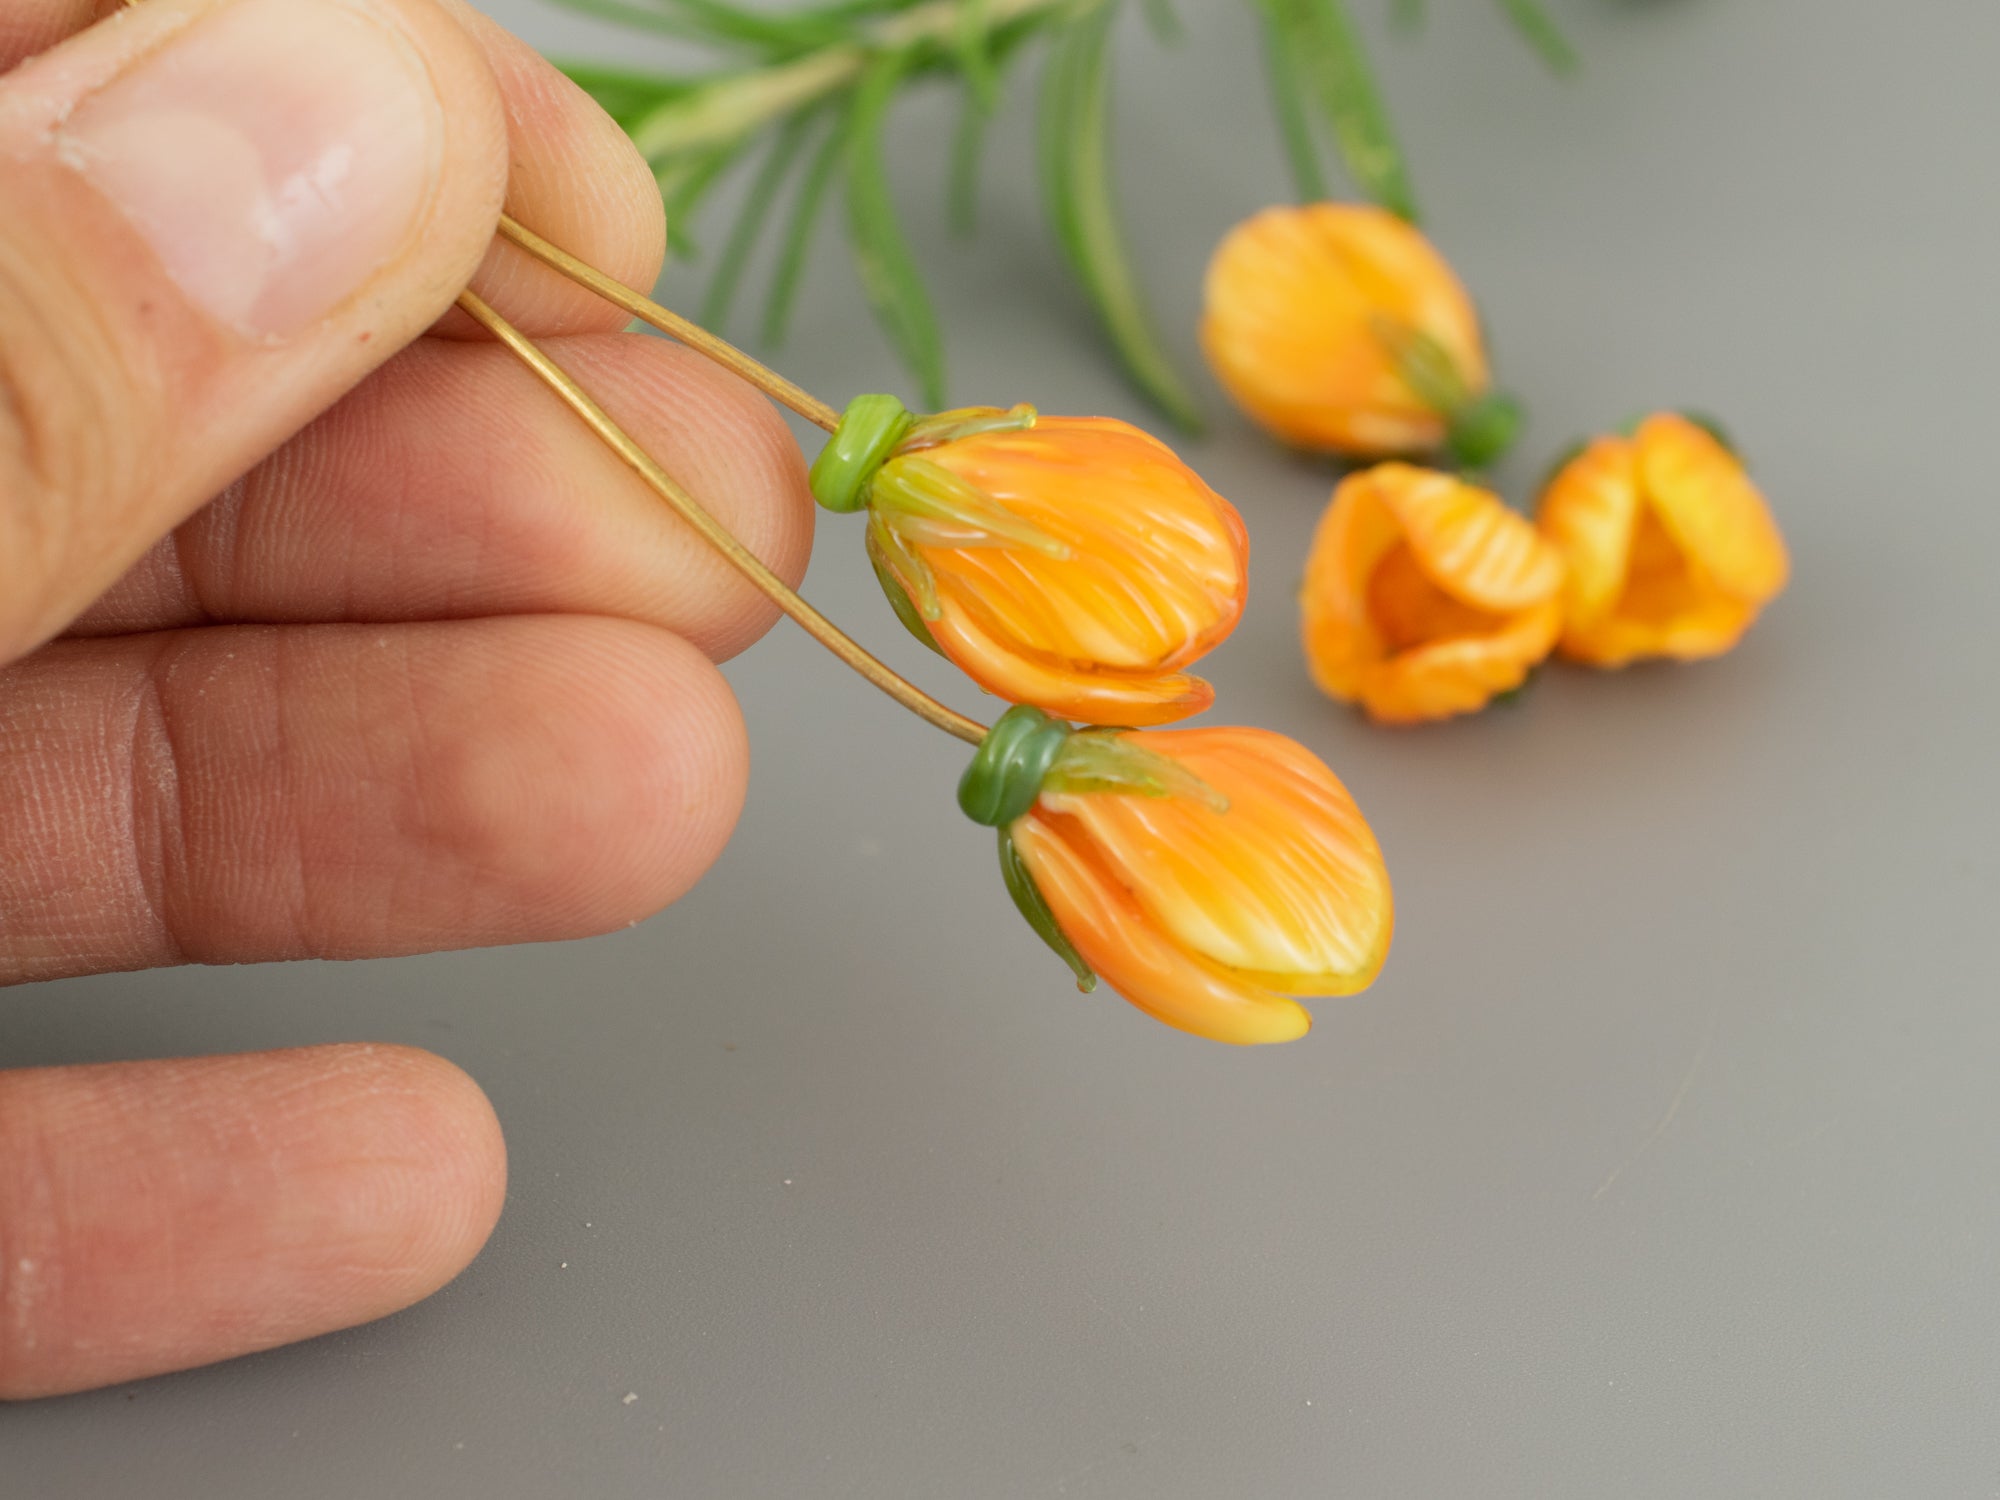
[0, 0, 506, 662]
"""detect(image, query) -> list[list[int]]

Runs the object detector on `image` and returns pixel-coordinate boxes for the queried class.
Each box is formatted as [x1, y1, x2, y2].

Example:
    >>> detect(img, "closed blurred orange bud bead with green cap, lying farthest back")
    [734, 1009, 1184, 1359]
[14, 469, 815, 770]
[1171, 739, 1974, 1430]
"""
[1202, 204, 1520, 466]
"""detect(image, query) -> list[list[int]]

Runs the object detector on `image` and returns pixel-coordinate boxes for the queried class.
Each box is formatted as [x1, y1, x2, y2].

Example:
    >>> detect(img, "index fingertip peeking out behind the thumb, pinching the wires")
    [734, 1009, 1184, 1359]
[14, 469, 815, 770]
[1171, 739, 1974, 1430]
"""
[432, 0, 666, 340]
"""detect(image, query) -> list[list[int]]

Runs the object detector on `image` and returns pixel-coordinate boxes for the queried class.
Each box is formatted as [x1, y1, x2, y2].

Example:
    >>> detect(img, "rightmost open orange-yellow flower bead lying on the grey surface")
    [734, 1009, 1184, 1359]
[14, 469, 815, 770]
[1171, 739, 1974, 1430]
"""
[1540, 412, 1790, 666]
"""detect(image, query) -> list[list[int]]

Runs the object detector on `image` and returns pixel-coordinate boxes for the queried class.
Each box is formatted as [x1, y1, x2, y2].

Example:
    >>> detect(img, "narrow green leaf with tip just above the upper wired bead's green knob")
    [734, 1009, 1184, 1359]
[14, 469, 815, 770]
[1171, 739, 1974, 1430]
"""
[842, 54, 944, 408]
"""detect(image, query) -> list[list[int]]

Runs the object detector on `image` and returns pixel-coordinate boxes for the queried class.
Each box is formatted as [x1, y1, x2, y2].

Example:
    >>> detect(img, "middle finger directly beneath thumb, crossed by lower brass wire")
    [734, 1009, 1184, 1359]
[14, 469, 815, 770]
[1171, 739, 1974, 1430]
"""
[74, 334, 814, 660]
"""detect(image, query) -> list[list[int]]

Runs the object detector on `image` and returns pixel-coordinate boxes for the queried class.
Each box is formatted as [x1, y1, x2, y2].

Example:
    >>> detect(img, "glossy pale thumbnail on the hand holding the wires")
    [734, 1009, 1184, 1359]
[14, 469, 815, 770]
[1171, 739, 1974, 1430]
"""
[58, 0, 444, 336]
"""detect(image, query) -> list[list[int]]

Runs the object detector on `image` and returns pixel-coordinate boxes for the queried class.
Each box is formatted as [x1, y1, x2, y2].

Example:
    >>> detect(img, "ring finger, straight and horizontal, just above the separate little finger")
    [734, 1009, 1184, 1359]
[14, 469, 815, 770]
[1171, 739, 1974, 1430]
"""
[0, 616, 748, 982]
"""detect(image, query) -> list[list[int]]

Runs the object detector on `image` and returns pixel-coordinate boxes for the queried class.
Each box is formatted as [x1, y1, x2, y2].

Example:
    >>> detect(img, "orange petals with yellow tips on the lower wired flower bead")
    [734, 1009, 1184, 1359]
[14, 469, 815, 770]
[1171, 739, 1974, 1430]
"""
[1008, 728, 1394, 1044]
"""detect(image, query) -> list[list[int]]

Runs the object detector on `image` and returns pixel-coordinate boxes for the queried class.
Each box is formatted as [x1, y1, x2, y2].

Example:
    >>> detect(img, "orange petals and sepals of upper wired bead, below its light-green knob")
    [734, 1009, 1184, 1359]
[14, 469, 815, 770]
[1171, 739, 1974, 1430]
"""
[868, 416, 1250, 724]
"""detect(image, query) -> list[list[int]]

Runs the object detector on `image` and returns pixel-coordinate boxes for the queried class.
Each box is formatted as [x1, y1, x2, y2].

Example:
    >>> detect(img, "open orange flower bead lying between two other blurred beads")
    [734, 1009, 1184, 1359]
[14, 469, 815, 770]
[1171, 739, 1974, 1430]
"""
[1300, 464, 1562, 724]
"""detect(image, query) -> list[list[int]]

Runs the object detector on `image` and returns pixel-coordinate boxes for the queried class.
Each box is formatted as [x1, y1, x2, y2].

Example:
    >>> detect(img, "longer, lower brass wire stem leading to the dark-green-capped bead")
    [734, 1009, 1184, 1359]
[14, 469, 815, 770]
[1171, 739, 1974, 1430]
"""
[458, 288, 986, 744]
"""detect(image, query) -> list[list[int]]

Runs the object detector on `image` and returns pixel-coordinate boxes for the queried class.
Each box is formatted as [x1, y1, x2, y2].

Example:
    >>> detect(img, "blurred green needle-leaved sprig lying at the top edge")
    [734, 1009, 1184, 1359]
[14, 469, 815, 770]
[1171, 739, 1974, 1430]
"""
[556, 0, 1576, 430]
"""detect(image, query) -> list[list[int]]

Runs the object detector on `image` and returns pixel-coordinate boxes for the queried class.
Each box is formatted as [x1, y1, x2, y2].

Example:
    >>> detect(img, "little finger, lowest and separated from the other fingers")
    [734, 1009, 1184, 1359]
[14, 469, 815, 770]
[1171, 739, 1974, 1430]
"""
[0, 1046, 506, 1400]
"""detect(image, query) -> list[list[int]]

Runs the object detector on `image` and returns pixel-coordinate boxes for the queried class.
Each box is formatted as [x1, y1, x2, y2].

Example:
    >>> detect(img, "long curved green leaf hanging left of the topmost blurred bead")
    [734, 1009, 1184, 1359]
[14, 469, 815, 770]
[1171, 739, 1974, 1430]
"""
[1042, 6, 1200, 432]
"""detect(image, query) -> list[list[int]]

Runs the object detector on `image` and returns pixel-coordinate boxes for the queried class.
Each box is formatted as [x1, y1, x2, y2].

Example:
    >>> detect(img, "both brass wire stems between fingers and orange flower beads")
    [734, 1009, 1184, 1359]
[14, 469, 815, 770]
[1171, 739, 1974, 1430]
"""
[458, 214, 986, 744]
